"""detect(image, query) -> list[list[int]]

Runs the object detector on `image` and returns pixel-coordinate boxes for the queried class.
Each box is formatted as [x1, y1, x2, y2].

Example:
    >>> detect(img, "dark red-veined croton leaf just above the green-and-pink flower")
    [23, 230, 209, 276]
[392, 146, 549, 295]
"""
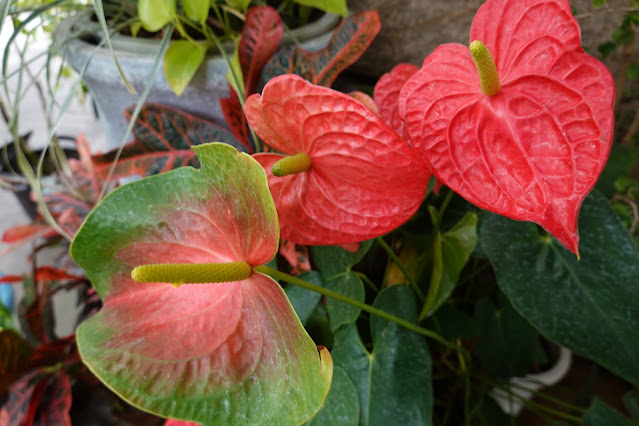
[93, 103, 240, 180]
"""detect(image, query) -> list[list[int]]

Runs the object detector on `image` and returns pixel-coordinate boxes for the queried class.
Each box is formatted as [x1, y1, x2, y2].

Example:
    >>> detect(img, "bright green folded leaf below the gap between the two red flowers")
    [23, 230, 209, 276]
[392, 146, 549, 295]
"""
[419, 212, 477, 321]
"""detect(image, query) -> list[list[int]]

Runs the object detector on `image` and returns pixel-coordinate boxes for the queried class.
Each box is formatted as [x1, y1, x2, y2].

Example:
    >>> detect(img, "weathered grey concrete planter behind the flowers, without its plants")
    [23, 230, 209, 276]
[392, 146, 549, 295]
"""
[56, 13, 339, 152]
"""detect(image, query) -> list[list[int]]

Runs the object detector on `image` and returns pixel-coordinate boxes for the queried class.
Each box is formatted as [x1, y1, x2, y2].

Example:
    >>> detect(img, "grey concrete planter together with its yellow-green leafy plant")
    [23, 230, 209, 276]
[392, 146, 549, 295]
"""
[48, 0, 346, 152]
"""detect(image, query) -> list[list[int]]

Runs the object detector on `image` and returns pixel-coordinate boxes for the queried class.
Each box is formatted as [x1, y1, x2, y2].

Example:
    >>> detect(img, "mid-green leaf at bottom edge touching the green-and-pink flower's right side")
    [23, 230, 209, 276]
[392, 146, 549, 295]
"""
[306, 366, 359, 426]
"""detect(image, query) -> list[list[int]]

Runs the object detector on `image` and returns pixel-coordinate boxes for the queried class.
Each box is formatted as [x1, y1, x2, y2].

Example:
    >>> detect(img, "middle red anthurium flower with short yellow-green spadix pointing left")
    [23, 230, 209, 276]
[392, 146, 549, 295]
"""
[245, 74, 430, 245]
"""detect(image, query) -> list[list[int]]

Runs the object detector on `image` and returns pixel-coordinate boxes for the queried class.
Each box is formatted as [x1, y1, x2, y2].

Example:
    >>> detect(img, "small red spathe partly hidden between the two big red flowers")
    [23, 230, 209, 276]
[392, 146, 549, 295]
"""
[373, 64, 419, 140]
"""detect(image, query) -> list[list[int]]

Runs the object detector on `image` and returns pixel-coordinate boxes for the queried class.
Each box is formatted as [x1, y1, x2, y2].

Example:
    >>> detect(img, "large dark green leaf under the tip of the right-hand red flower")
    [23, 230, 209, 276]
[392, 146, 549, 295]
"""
[480, 192, 639, 385]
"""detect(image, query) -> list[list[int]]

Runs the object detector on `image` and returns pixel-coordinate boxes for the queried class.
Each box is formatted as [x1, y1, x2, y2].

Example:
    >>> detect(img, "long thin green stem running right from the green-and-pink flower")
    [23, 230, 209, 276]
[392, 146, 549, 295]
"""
[253, 265, 469, 357]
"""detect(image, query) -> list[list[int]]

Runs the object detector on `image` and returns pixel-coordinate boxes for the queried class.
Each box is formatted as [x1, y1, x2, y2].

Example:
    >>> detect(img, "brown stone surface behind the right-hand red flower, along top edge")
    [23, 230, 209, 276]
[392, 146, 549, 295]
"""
[349, 0, 639, 77]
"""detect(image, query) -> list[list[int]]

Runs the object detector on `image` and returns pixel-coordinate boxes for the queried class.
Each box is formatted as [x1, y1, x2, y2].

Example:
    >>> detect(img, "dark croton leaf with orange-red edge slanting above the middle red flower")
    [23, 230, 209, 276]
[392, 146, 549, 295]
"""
[262, 11, 381, 87]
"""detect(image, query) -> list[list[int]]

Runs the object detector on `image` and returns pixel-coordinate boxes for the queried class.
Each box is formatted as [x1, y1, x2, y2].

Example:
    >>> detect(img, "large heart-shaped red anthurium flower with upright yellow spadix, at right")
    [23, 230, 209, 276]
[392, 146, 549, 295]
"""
[399, 0, 614, 253]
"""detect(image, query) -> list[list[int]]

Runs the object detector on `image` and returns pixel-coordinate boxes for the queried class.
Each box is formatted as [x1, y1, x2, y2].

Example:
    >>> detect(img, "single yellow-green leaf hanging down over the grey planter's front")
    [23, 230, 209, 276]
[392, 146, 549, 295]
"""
[164, 40, 206, 96]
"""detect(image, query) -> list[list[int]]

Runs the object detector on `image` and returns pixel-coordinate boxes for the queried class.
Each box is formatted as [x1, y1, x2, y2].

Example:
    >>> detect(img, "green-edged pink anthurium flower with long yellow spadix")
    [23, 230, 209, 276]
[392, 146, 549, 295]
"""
[71, 143, 333, 424]
